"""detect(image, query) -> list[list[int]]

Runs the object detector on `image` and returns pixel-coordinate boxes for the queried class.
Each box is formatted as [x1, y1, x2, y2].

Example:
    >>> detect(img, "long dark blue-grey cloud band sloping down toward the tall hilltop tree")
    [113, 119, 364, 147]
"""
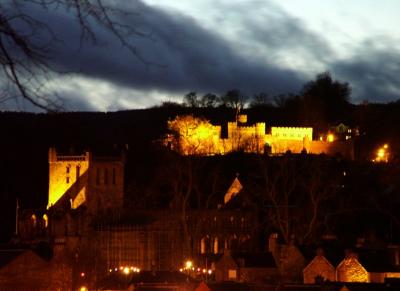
[17, 1, 303, 105]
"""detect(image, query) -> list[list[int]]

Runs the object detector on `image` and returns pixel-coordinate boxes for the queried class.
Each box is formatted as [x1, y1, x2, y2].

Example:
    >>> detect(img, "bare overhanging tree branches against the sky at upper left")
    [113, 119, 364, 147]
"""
[0, 0, 150, 111]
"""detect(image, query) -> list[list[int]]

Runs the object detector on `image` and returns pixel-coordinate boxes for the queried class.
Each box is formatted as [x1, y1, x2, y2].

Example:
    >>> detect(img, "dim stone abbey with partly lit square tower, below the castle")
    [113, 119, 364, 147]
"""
[15, 148, 256, 288]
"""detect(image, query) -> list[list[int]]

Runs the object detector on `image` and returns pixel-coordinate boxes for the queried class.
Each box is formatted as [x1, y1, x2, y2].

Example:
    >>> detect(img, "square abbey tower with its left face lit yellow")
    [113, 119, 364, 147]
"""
[47, 148, 124, 213]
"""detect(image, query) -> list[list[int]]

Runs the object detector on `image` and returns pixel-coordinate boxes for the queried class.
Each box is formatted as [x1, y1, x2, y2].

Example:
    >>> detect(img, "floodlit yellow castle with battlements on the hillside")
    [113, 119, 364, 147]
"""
[165, 114, 354, 159]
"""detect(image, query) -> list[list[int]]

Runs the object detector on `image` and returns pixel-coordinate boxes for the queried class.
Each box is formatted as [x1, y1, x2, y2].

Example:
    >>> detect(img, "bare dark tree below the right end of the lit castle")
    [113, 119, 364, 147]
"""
[252, 154, 340, 244]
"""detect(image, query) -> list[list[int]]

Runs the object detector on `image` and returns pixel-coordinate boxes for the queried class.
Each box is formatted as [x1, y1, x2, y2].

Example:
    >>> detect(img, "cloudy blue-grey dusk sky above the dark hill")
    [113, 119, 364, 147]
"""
[0, 0, 400, 111]
